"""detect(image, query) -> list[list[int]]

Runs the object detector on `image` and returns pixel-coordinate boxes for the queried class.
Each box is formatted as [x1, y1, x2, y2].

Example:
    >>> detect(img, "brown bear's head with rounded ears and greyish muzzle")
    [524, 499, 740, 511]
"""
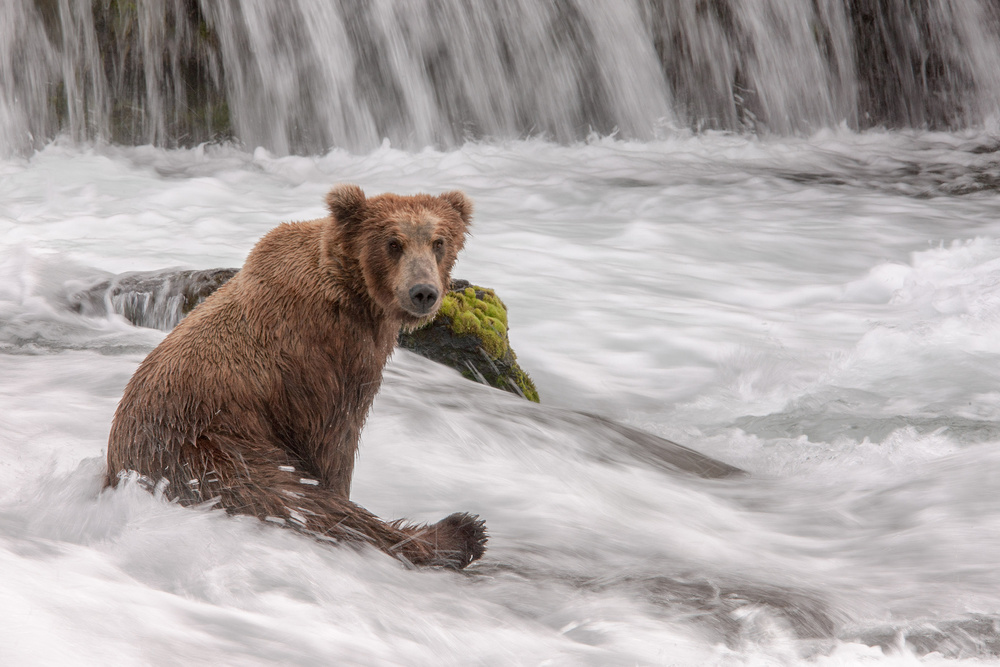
[326, 185, 472, 327]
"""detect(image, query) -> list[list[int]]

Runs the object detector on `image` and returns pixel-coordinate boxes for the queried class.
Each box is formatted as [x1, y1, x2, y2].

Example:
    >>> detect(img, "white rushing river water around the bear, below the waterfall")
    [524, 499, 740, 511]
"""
[0, 129, 1000, 665]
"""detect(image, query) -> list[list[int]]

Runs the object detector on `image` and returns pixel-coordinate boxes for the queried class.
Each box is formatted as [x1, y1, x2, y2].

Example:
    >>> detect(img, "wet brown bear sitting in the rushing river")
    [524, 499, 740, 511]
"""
[105, 185, 486, 568]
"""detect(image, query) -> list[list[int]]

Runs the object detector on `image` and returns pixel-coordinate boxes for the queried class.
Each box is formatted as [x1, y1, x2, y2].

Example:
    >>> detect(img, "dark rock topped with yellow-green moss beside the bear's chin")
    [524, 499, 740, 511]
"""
[399, 280, 539, 403]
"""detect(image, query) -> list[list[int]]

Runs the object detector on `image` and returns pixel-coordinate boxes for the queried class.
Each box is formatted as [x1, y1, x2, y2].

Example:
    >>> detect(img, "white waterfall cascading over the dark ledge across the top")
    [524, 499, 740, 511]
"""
[0, 0, 1000, 154]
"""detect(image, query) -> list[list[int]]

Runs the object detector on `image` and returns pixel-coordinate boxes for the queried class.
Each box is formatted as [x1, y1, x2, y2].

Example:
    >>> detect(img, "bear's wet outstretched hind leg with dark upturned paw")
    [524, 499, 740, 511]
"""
[149, 436, 487, 569]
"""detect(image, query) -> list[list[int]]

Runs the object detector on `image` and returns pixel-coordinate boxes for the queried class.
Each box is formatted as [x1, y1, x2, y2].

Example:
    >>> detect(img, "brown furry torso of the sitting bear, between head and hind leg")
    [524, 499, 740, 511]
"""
[108, 220, 395, 490]
